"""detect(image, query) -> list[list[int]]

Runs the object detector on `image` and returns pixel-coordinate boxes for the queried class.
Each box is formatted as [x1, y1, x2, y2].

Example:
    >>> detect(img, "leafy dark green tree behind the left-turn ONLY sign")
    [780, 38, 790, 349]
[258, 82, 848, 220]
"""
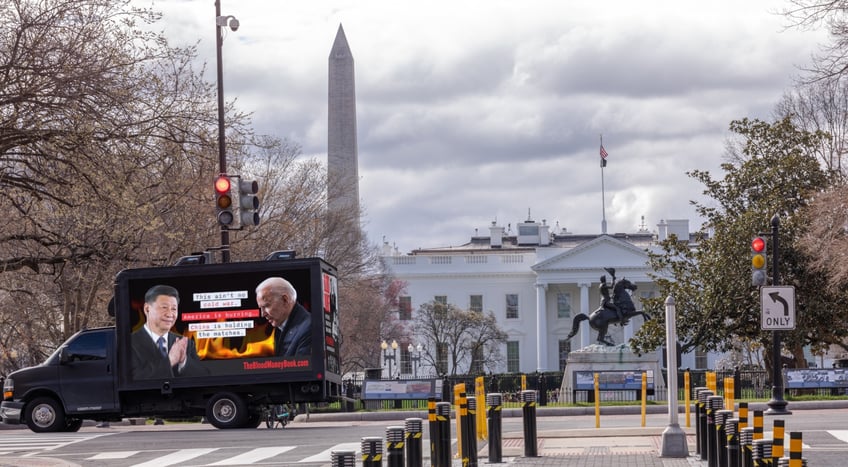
[632, 117, 846, 378]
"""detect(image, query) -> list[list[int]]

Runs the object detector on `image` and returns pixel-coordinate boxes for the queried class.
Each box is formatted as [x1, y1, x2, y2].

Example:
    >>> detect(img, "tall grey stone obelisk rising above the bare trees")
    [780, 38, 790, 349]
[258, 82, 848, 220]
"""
[327, 24, 360, 225]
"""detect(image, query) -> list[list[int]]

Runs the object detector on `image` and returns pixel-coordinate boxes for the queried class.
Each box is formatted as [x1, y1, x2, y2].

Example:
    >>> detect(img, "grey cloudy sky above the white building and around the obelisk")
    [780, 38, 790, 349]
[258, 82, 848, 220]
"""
[153, 0, 826, 253]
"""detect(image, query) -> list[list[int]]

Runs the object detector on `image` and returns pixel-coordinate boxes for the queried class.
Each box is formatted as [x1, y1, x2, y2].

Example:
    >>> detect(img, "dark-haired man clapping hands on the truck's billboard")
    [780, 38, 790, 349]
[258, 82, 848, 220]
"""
[131, 285, 209, 380]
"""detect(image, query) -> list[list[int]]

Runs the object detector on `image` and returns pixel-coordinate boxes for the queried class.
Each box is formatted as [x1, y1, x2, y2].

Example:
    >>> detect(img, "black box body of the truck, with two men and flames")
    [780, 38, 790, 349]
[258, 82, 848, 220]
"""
[116, 259, 339, 385]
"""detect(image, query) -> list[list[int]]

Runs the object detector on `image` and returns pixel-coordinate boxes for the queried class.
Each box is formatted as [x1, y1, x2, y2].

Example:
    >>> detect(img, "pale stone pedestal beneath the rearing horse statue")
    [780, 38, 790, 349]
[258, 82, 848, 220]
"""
[560, 344, 666, 403]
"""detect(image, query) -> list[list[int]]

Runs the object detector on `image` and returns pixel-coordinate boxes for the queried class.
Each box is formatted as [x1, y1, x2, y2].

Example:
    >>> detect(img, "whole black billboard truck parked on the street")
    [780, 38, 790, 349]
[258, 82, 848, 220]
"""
[0, 258, 342, 432]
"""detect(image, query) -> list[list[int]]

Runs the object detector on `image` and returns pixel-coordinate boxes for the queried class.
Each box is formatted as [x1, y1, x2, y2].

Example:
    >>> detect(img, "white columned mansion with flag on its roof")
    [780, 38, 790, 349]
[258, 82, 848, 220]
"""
[383, 219, 716, 374]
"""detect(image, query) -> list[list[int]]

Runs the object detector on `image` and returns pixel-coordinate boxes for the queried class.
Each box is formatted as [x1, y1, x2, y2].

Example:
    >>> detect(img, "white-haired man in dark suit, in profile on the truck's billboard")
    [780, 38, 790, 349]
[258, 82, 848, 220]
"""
[256, 277, 312, 357]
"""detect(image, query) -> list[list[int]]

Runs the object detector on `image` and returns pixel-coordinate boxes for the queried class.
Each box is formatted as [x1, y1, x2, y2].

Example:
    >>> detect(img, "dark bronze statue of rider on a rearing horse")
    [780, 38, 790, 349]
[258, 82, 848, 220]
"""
[567, 268, 651, 346]
